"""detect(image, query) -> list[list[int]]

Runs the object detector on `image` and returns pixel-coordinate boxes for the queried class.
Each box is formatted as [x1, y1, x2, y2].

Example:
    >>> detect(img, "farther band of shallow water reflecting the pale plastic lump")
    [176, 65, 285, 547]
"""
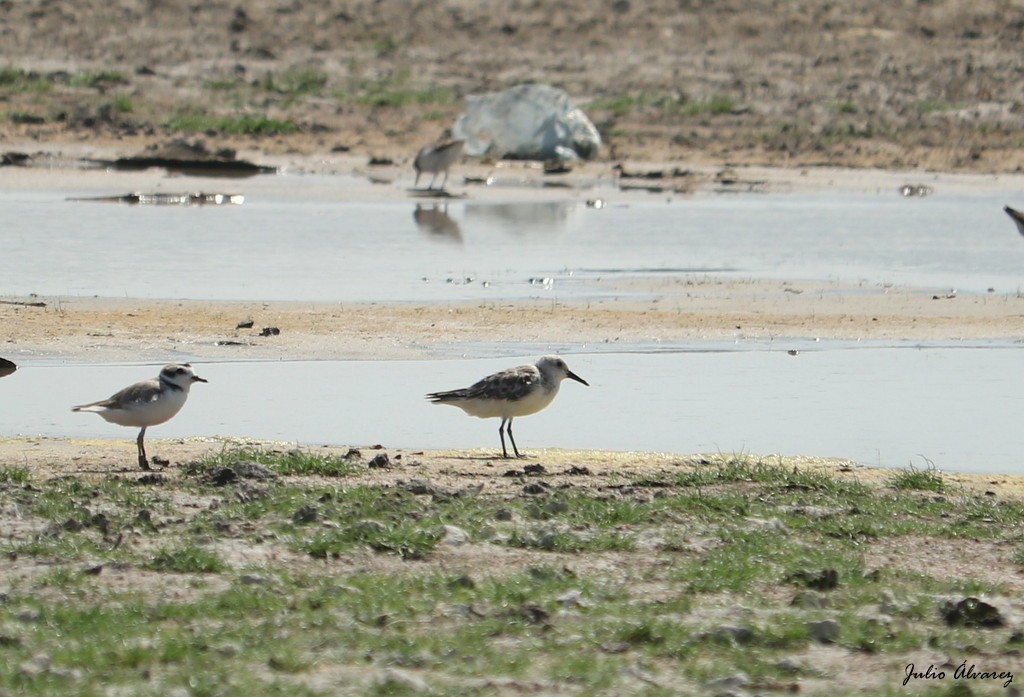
[0, 175, 1024, 302]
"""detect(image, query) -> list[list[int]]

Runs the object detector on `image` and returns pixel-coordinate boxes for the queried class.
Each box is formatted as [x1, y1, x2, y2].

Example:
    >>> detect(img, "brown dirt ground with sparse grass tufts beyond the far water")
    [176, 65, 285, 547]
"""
[0, 0, 1024, 172]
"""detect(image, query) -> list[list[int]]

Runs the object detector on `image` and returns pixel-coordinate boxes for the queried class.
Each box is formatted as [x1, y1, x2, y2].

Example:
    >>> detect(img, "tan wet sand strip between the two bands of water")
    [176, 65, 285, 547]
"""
[0, 277, 1024, 362]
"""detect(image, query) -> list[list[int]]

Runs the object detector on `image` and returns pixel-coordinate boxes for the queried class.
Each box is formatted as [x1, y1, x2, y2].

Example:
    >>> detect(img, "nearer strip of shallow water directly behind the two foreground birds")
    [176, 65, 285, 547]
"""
[0, 348, 1024, 473]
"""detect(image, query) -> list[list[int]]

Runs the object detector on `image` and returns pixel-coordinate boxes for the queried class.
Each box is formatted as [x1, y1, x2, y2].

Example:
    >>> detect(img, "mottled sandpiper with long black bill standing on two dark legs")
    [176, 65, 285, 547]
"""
[427, 356, 590, 458]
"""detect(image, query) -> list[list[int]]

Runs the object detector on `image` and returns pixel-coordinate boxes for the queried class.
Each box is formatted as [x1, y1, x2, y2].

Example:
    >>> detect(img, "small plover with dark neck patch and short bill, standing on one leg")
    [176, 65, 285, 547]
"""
[72, 363, 207, 470]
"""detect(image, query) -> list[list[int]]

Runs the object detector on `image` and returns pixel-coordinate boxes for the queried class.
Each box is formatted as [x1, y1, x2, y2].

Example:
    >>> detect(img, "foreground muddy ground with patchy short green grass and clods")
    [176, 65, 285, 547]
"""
[0, 448, 1024, 697]
